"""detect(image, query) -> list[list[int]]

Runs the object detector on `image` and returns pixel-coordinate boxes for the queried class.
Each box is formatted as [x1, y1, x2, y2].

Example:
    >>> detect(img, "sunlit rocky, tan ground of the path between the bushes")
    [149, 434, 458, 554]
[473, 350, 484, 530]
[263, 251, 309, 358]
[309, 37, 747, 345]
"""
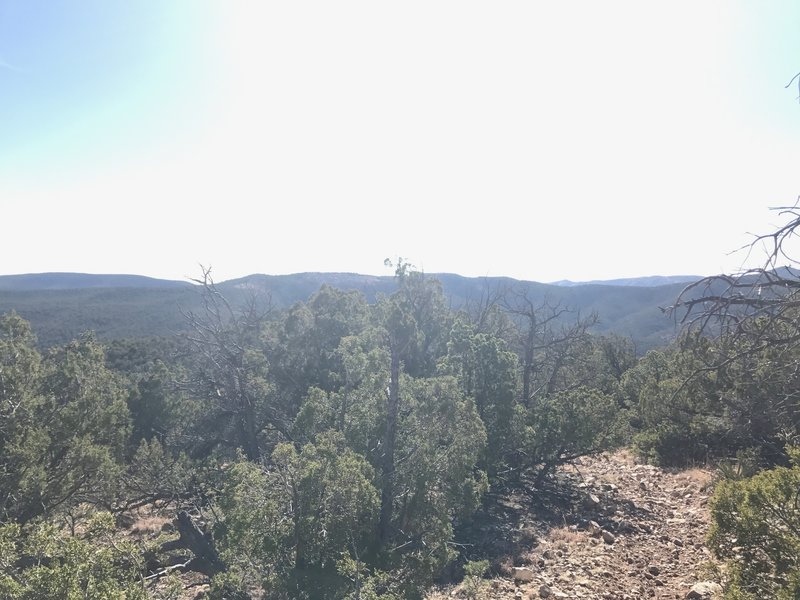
[429, 453, 721, 600]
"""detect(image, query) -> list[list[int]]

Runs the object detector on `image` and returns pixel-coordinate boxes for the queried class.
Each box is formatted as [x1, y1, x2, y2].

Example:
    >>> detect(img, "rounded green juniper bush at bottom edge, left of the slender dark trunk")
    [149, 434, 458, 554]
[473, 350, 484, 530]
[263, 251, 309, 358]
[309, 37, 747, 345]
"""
[209, 433, 378, 598]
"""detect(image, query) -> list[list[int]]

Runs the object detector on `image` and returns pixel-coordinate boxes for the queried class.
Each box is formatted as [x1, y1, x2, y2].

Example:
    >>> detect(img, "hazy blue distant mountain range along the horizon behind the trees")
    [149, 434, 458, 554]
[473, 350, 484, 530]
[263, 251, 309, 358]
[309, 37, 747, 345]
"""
[0, 273, 700, 352]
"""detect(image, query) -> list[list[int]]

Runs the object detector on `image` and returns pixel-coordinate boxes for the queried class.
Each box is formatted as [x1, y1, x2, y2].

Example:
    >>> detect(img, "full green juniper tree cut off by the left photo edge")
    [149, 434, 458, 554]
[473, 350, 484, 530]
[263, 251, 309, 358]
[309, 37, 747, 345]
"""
[0, 313, 130, 522]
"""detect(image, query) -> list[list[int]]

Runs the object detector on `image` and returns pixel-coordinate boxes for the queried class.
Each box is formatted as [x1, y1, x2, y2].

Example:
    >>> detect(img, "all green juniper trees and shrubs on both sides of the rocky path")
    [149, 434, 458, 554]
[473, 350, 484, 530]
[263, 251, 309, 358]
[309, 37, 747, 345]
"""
[0, 233, 800, 600]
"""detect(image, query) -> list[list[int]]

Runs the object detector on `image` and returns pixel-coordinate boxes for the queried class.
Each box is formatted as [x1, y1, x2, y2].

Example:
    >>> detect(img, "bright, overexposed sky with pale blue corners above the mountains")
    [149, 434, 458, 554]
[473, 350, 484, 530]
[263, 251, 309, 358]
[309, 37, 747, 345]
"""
[0, 0, 800, 281]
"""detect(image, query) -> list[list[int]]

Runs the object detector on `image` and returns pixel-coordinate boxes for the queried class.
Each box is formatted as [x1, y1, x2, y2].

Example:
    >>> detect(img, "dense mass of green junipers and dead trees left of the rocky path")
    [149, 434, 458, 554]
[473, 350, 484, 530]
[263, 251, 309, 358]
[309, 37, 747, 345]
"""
[0, 262, 634, 599]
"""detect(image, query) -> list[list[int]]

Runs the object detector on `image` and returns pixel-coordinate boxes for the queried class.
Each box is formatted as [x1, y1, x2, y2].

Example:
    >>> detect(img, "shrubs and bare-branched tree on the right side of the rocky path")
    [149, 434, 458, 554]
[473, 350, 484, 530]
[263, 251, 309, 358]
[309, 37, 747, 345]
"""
[648, 204, 800, 599]
